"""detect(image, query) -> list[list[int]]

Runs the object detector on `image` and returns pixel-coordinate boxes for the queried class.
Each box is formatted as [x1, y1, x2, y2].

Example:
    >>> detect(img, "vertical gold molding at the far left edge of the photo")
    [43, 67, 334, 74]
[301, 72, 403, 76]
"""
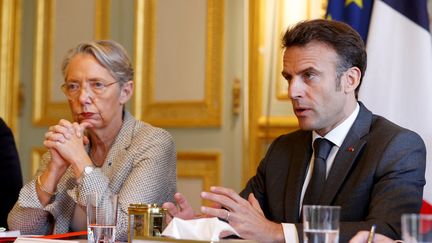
[0, 0, 21, 132]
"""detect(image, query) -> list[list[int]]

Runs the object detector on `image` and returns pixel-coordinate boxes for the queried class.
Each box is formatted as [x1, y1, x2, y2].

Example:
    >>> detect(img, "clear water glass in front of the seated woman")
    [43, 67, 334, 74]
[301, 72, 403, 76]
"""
[87, 194, 117, 243]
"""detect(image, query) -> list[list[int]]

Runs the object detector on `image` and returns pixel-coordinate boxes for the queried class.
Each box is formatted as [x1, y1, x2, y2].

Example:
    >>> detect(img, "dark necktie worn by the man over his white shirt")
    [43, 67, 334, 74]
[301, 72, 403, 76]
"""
[303, 138, 334, 205]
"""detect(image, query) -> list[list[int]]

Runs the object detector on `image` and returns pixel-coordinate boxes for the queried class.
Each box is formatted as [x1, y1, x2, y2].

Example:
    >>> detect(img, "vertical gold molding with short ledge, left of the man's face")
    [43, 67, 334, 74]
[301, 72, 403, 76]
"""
[246, 0, 297, 184]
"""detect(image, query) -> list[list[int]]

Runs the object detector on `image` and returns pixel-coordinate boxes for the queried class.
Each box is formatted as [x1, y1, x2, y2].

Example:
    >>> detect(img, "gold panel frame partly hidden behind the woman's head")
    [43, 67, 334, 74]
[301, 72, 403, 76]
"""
[33, 0, 110, 126]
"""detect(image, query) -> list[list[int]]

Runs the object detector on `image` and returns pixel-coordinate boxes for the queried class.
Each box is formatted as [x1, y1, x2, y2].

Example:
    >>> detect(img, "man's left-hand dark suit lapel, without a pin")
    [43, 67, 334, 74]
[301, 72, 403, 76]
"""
[285, 132, 312, 222]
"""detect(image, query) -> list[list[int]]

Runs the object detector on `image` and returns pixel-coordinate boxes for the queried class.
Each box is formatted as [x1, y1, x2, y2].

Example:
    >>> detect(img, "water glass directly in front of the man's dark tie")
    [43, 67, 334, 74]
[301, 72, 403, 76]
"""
[303, 205, 340, 243]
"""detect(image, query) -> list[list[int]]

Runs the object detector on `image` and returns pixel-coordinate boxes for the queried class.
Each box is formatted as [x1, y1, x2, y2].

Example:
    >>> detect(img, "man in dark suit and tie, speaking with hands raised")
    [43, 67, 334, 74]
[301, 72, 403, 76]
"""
[164, 20, 426, 242]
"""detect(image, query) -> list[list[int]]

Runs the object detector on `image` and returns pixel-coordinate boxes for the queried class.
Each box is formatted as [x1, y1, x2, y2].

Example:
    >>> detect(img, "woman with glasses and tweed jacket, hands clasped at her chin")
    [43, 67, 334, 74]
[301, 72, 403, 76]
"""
[8, 40, 176, 241]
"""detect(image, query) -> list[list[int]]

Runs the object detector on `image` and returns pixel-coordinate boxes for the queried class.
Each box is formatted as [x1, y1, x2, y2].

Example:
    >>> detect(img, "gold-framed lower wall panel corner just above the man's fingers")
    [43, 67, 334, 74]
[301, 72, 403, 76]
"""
[177, 151, 220, 205]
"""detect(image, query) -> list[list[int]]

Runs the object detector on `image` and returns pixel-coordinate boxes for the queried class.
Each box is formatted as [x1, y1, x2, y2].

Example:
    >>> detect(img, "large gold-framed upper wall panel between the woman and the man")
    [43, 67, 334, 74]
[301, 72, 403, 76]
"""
[132, 0, 224, 127]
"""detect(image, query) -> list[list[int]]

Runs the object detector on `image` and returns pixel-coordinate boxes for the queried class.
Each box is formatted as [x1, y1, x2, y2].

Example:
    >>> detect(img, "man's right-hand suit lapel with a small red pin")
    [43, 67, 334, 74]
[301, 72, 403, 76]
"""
[320, 102, 372, 205]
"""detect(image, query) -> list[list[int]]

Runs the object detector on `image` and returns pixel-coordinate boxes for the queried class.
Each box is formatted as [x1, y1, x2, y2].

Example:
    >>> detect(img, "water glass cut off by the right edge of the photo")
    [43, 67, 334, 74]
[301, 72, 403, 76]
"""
[401, 214, 432, 243]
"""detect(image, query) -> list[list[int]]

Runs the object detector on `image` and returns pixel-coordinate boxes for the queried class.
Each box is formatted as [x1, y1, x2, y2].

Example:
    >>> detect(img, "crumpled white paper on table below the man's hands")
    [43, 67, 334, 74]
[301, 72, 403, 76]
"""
[162, 217, 239, 241]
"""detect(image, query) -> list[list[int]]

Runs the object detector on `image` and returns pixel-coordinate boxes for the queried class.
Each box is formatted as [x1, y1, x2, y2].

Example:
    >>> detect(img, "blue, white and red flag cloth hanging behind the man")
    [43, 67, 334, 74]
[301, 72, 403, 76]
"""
[327, 0, 432, 214]
